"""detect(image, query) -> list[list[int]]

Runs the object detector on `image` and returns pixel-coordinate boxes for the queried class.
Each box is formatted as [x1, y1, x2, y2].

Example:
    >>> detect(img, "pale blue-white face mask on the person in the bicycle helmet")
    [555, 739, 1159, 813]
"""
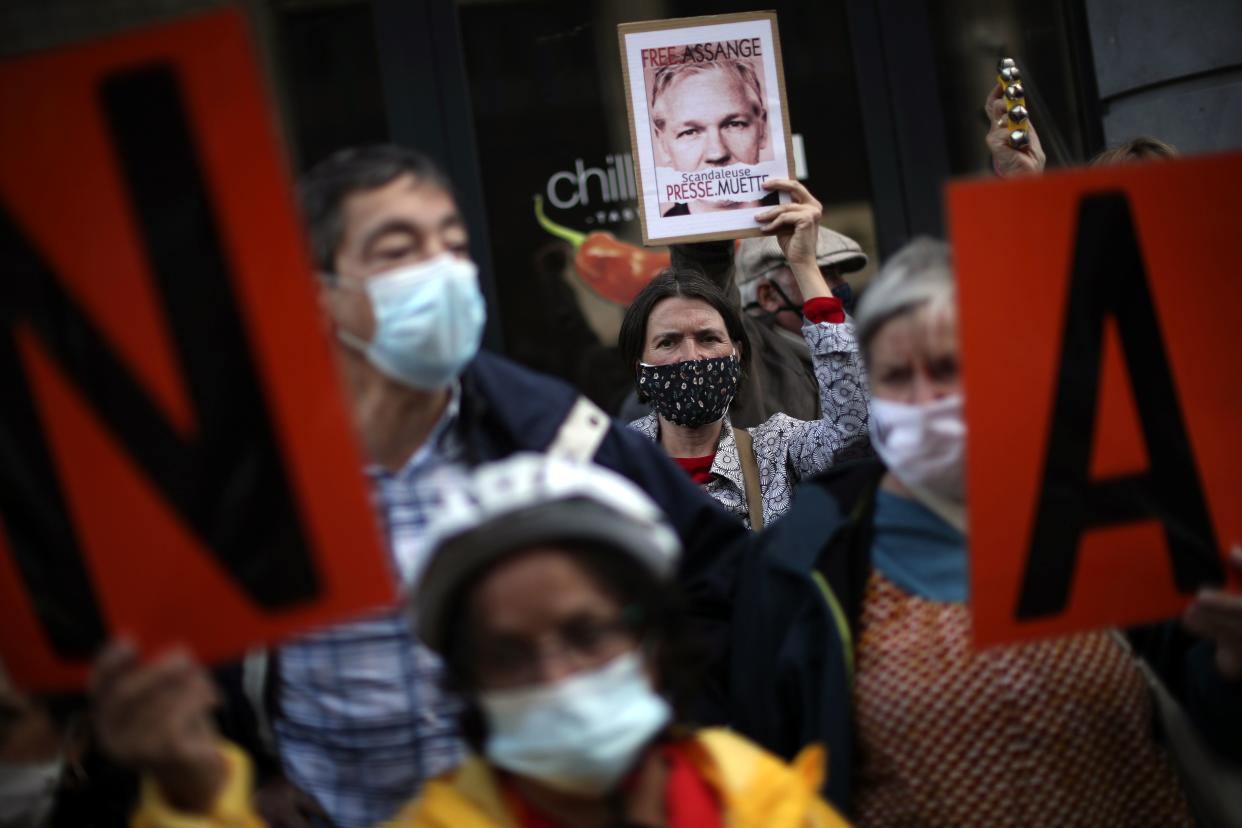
[478, 652, 672, 796]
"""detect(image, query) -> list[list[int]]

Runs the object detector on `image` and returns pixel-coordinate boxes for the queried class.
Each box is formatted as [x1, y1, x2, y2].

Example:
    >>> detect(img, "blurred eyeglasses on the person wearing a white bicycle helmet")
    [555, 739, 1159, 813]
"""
[474, 607, 641, 688]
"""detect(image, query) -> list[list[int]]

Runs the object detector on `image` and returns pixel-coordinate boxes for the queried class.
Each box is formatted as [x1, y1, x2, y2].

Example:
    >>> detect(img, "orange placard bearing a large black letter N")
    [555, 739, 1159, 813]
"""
[0, 11, 392, 688]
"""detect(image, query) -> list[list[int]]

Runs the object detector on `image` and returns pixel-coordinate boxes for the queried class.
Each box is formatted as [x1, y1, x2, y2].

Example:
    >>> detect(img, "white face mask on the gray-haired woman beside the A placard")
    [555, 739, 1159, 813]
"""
[871, 394, 966, 503]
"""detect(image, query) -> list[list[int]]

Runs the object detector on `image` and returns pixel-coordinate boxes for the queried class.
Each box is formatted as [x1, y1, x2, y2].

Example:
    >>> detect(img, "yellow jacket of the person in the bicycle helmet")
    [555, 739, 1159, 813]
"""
[133, 729, 848, 828]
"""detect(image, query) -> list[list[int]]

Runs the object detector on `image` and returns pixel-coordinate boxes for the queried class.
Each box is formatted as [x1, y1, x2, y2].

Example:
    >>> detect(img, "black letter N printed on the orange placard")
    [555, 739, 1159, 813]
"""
[0, 63, 320, 659]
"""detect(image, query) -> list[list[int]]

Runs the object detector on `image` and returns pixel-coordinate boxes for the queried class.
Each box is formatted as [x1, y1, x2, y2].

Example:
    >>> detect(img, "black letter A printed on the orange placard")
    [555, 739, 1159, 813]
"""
[1017, 192, 1225, 619]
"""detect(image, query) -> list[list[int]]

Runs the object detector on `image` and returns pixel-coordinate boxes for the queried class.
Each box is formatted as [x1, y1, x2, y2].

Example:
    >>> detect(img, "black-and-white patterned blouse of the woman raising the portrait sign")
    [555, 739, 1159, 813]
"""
[630, 322, 871, 528]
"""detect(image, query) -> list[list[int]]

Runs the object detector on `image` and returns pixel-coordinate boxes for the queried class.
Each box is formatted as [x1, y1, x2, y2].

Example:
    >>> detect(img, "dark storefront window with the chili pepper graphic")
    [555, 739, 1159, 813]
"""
[458, 0, 876, 411]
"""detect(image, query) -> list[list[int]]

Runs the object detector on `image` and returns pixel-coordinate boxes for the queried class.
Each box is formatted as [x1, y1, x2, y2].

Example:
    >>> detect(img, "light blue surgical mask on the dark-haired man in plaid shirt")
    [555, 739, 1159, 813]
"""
[338, 253, 487, 390]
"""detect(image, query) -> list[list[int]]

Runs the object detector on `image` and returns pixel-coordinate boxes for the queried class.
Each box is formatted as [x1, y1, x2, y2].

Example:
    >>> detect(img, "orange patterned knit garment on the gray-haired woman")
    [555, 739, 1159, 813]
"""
[854, 570, 1192, 828]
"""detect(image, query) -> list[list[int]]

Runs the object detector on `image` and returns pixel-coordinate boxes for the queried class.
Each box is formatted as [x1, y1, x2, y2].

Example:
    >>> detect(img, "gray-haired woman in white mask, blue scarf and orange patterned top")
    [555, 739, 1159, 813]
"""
[705, 240, 1242, 826]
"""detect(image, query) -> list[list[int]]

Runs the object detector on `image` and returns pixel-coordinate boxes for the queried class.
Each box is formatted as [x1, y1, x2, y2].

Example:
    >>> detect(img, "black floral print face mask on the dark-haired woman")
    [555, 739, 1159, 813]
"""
[638, 354, 741, 427]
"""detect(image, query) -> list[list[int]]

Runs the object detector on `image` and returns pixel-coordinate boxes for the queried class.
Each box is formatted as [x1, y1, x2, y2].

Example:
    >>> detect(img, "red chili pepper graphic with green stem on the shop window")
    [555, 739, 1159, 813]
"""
[535, 196, 671, 305]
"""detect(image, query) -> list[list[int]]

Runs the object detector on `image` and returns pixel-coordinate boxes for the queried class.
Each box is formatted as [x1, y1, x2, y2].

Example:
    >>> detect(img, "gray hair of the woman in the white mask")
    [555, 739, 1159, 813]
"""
[854, 236, 956, 358]
